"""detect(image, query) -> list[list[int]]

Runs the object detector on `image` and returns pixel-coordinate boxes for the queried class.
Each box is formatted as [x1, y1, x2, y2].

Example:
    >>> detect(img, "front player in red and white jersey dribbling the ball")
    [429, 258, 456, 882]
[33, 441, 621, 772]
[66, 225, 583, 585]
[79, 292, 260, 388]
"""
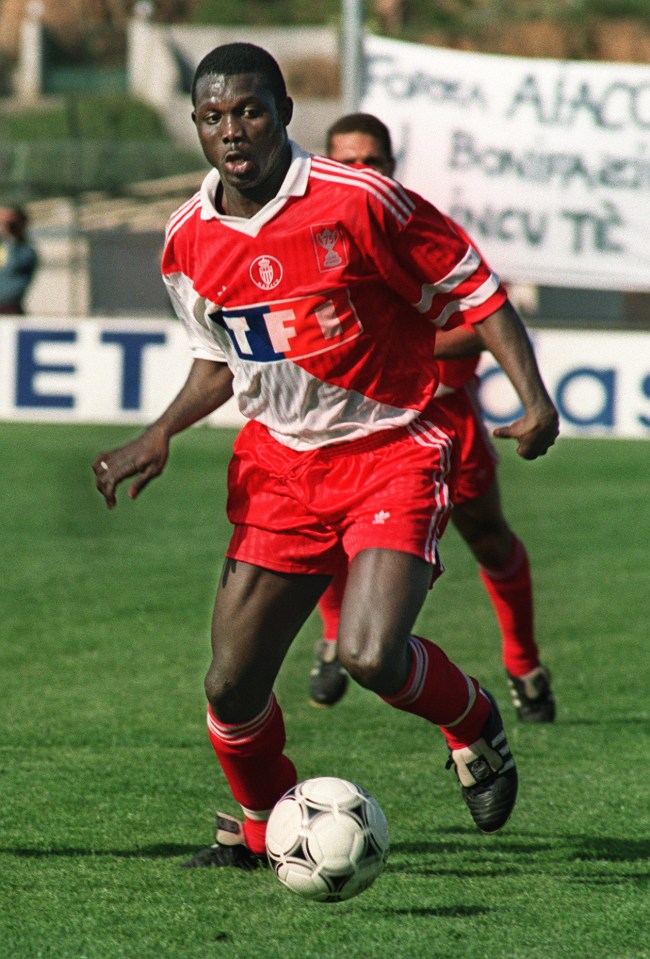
[93, 43, 558, 869]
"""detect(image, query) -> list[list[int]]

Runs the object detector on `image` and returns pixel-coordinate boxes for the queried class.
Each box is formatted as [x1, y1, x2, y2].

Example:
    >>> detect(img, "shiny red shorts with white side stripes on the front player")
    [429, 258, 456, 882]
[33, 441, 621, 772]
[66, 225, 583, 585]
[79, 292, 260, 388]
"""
[227, 406, 455, 575]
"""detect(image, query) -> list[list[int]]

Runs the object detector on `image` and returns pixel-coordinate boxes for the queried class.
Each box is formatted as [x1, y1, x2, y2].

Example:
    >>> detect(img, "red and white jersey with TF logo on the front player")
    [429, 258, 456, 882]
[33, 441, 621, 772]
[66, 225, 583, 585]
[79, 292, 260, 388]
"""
[162, 144, 506, 450]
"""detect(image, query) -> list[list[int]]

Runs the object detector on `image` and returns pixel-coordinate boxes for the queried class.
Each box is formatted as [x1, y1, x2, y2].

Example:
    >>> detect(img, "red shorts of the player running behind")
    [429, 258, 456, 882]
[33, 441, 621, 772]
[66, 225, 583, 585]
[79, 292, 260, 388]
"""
[436, 377, 499, 503]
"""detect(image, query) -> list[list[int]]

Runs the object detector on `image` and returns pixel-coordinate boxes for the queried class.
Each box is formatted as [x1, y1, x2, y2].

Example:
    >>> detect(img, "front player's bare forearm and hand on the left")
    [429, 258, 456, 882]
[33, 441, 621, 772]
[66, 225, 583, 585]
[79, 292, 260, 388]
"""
[92, 359, 232, 509]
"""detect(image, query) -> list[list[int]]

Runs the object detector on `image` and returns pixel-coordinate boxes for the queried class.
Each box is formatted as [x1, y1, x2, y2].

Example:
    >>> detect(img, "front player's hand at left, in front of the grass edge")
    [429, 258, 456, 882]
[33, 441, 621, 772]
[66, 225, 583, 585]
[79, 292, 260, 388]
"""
[92, 427, 169, 509]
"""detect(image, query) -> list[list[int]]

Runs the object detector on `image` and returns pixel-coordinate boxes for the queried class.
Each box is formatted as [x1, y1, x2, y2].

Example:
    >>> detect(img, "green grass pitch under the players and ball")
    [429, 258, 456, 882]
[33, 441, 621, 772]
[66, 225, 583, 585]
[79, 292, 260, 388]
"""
[0, 423, 650, 959]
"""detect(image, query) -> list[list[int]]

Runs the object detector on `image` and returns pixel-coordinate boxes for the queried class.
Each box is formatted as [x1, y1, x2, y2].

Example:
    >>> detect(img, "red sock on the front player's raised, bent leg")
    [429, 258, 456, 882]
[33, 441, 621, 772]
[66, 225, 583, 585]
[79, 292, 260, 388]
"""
[383, 636, 490, 749]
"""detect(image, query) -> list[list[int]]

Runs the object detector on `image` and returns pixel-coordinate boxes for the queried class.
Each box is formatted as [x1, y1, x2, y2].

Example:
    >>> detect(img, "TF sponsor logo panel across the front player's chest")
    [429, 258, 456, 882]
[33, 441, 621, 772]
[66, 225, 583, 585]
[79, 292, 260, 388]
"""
[210, 289, 363, 363]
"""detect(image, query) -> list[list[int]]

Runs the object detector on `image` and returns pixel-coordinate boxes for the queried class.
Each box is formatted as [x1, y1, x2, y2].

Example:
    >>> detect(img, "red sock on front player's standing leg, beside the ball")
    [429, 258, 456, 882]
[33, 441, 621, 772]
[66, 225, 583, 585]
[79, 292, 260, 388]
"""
[208, 693, 297, 853]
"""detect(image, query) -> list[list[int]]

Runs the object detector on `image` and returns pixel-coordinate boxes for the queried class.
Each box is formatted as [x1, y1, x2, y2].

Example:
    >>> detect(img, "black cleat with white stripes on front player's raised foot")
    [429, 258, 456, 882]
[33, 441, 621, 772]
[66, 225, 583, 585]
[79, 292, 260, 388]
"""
[447, 689, 518, 833]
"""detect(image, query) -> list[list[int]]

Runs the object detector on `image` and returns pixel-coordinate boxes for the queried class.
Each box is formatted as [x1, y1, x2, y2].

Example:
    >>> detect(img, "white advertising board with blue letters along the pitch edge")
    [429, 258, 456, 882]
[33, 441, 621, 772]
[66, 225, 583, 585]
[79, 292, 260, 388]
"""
[0, 317, 650, 439]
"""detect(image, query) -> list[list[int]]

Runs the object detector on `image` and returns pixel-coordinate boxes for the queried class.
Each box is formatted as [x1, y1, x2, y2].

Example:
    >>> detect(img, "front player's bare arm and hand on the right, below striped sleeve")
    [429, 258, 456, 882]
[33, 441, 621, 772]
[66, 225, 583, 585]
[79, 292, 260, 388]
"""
[474, 301, 560, 460]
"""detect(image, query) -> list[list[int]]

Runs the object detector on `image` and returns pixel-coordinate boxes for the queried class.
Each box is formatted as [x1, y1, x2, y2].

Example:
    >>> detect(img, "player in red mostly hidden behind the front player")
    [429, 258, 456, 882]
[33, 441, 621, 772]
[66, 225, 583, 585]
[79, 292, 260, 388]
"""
[309, 113, 555, 723]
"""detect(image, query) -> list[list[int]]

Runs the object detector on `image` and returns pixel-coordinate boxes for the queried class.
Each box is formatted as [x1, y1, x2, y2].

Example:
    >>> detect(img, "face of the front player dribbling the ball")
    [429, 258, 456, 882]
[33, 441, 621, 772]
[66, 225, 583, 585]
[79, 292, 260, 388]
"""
[192, 73, 292, 214]
